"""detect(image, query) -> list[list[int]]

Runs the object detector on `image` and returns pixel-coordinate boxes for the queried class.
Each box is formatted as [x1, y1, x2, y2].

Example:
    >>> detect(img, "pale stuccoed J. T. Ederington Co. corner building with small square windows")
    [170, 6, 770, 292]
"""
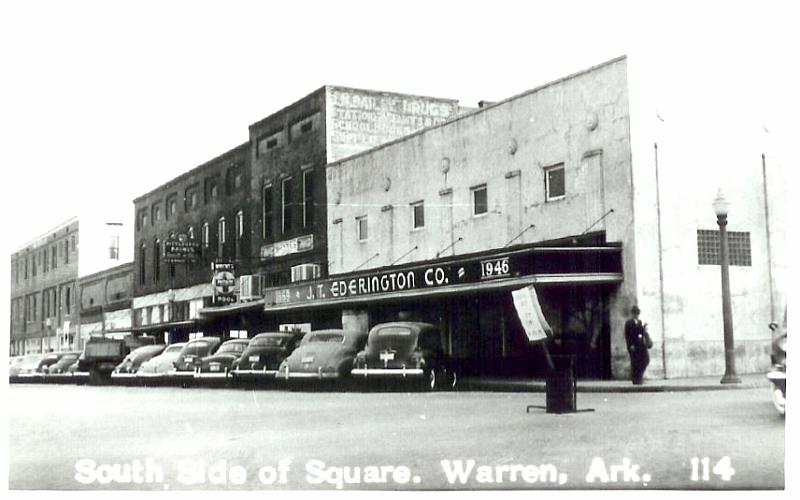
[265, 57, 787, 378]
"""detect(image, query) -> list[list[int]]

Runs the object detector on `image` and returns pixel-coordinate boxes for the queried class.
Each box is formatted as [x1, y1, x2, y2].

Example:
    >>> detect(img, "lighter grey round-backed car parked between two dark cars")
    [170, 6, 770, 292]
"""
[276, 330, 367, 380]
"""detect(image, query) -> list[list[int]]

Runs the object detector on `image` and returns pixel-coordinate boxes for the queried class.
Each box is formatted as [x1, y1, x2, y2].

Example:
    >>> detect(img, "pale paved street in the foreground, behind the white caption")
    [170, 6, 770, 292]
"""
[8, 385, 784, 490]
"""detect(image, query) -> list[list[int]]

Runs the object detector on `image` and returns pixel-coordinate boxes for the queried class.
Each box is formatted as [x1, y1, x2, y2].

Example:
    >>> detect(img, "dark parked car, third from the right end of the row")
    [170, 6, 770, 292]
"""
[231, 332, 303, 380]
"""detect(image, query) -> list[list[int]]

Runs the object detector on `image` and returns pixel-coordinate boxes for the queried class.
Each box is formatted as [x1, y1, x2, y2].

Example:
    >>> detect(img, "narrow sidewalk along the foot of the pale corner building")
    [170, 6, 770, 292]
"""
[458, 373, 770, 392]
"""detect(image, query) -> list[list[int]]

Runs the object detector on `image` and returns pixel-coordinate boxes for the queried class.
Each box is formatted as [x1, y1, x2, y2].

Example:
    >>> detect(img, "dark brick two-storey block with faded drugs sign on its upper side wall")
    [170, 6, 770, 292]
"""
[128, 86, 459, 342]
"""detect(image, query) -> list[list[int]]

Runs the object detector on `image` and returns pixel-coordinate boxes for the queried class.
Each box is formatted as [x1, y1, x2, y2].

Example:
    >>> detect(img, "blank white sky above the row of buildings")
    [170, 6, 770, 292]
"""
[0, 0, 800, 254]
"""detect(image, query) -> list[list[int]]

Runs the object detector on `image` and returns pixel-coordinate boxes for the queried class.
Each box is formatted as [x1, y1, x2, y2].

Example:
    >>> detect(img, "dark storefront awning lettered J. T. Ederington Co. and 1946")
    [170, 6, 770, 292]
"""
[264, 241, 623, 312]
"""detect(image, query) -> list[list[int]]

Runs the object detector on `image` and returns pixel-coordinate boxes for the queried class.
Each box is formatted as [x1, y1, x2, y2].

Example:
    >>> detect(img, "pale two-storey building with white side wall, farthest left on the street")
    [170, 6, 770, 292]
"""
[9, 215, 133, 355]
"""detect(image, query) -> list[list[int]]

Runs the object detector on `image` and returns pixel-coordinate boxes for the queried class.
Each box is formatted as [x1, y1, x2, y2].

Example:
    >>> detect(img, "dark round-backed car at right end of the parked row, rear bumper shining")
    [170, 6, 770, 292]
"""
[352, 322, 457, 390]
